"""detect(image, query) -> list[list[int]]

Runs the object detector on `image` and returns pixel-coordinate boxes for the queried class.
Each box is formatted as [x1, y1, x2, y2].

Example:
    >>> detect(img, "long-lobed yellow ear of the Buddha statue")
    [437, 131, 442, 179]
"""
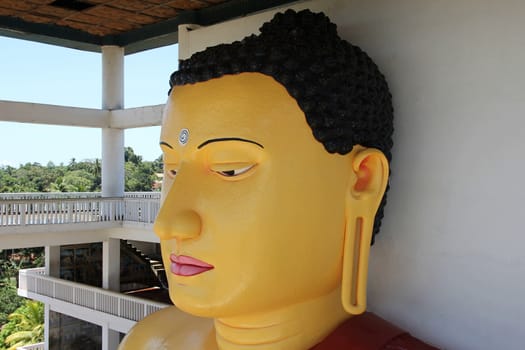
[341, 146, 389, 315]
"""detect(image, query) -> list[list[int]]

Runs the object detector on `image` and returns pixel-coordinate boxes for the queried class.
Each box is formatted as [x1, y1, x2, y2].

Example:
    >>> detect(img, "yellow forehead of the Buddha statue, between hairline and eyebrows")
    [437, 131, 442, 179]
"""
[161, 73, 313, 147]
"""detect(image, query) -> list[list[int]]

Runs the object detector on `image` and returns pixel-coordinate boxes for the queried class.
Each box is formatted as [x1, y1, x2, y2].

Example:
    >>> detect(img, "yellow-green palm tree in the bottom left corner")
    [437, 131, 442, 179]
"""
[5, 300, 44, 350]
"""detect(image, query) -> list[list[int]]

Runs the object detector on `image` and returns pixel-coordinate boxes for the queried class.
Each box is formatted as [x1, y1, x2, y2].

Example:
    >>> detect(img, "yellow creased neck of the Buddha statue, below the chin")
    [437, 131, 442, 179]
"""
[215, 289, 350, 350]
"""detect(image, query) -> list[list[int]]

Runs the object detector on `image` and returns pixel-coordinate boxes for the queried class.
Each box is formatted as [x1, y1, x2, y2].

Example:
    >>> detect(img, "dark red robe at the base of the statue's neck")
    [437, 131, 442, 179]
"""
[310, 312, 437, 350]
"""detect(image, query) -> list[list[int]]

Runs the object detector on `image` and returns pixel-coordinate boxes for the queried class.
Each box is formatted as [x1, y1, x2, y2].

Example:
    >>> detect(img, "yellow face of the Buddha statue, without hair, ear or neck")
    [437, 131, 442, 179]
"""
[154, 73, 351, 317]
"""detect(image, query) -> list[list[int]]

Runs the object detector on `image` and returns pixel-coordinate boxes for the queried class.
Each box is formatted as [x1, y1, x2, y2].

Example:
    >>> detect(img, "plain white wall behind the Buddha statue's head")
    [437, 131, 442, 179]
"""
[181, 0, 525, 350]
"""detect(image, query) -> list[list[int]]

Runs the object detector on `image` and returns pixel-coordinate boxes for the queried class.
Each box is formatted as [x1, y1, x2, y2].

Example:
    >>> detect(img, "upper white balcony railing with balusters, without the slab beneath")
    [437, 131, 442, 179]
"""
[0, 192, 160, 227]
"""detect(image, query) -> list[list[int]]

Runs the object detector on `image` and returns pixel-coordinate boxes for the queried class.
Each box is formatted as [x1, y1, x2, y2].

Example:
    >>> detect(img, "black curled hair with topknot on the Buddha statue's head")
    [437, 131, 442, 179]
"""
[170, 10, 393, 243]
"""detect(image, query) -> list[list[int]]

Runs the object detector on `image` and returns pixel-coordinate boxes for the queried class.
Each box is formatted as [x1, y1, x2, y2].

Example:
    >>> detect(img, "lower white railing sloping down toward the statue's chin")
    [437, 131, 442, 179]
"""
[18, 268, 169, 321]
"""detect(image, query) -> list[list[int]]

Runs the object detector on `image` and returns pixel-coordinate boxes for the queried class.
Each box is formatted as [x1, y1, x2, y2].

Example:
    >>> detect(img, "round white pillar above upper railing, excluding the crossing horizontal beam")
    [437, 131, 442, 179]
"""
[102, 46, 124, 197]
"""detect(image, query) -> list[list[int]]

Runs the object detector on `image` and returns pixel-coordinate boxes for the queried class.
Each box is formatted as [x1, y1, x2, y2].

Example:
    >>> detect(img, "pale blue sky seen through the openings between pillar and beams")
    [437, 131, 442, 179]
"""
[0, 37, 178, 166]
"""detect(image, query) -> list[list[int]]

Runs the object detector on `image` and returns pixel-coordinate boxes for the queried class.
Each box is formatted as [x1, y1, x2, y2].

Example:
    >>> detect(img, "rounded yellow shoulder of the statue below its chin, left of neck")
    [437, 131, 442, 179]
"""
[119, 306, 217, 350]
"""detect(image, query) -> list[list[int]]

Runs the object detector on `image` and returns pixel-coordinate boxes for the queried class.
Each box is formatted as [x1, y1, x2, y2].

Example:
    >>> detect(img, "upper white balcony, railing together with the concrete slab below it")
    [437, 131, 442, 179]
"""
[0, 192, 160, 249]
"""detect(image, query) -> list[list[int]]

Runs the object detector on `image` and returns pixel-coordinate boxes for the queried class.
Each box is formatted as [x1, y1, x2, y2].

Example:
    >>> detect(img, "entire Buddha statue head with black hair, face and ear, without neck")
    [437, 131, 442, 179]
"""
[154, 10, 393, 318]
